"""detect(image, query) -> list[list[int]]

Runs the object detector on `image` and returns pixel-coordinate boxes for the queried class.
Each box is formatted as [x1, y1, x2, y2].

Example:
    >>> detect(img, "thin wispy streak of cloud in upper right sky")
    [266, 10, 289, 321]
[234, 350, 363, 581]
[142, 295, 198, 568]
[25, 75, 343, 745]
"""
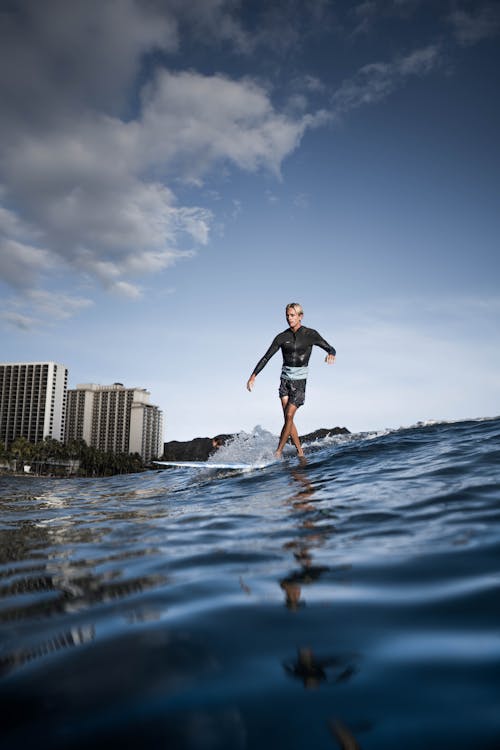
[332, 45, 441, 116]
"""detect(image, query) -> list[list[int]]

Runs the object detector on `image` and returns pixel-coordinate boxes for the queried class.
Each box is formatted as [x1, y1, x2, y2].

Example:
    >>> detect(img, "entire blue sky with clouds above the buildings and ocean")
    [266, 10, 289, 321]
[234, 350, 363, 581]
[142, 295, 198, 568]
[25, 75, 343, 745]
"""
[0, 0, 500, 440]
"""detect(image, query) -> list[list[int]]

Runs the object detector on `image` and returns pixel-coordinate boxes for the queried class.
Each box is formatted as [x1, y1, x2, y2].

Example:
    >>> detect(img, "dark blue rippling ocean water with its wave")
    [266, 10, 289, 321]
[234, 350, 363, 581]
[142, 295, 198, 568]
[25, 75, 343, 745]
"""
[0, 419, 500, 750]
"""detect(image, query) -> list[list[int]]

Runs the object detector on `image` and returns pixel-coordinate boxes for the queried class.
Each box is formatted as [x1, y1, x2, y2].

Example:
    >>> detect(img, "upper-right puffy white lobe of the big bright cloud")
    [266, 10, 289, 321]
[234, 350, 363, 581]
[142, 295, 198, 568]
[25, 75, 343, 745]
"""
[138, 70, 321, 179]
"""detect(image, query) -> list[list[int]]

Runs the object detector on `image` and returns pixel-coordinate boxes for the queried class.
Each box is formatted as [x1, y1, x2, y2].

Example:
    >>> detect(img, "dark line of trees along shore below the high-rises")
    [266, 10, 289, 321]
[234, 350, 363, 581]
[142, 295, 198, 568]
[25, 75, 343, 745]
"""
[0, 437, 145, 477]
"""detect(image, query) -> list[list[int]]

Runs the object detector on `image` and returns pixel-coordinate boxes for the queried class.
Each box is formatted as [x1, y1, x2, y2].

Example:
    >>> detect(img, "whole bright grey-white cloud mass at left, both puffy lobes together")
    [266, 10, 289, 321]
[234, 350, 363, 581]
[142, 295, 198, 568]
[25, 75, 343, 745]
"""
[0, 59, 323, 296]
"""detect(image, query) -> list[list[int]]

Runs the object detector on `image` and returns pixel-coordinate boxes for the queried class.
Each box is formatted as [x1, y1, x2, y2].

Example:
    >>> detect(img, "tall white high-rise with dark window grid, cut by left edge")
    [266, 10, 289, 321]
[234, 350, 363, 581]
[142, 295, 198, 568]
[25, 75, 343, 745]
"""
[0, 362, 68, 446]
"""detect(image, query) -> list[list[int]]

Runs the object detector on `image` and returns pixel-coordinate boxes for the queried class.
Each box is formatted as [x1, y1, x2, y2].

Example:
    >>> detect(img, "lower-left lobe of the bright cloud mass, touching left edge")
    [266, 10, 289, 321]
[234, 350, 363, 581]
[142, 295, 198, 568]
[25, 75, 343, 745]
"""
[0, 117, 211, 284]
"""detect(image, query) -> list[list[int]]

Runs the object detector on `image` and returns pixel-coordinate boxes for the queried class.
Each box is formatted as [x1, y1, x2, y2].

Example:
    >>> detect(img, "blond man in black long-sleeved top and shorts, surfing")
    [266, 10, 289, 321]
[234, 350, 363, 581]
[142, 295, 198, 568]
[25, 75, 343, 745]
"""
[247, 302, 336, 458]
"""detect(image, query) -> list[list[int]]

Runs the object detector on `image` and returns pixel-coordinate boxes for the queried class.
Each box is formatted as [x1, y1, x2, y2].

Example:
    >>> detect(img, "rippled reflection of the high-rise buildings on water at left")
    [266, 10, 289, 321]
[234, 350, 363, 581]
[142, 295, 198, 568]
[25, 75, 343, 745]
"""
[0, 508, 167, 675]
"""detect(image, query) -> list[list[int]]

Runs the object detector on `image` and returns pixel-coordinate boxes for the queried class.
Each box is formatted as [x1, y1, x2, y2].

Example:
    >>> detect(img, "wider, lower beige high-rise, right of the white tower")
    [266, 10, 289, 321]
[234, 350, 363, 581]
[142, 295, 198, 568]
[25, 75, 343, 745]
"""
[65, 383, 163, 461]
